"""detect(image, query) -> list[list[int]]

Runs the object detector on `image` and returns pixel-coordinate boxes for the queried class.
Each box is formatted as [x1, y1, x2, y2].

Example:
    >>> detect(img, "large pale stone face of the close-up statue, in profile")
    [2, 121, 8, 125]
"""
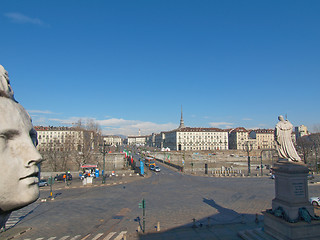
[0, 97, 41, 211]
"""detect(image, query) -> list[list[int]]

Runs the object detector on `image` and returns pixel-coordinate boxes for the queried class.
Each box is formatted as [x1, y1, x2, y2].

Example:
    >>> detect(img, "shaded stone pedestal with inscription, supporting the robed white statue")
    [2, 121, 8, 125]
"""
[264, 162, 320, 240]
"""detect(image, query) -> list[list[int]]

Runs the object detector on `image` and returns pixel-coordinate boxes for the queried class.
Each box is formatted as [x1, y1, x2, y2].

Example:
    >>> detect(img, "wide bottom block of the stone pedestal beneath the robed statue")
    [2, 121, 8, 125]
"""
[263, 212, 320, 240]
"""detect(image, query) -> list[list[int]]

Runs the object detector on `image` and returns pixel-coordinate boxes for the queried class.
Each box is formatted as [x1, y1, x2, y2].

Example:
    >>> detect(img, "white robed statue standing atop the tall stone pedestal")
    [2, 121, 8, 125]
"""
[274, 115, 301, 162]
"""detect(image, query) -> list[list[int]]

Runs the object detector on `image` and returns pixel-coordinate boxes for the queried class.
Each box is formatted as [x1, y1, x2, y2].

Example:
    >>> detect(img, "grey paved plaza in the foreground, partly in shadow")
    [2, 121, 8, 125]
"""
[0, 166, 320, 240]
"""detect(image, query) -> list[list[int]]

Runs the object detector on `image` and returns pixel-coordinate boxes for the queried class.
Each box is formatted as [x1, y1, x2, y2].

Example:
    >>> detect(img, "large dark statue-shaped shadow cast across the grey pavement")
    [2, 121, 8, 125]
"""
[139, 198, 263, 240]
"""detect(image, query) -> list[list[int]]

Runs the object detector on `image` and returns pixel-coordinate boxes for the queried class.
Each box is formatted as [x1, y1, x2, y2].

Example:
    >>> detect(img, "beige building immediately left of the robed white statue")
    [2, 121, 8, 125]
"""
[249, 129, 275, 149]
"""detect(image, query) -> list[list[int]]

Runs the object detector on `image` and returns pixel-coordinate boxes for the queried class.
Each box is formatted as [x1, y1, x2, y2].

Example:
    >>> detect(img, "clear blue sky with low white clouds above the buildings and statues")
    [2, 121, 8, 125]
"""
[0, 0, 320, 135]
